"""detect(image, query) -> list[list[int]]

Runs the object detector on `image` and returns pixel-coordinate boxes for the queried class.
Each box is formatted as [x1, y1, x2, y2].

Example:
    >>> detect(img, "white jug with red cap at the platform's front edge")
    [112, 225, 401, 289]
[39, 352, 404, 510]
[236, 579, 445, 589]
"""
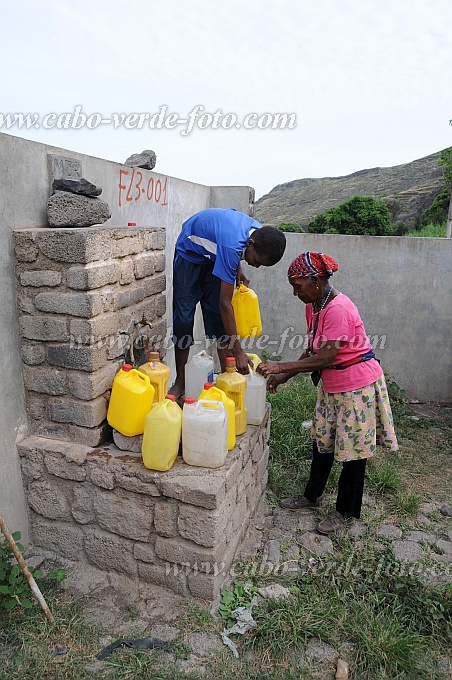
[182, 397, 228, 468]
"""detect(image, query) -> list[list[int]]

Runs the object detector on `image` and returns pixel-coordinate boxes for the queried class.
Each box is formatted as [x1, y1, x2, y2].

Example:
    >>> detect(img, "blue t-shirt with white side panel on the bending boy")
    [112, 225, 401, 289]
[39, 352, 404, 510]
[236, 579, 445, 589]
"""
[176, 208, 262, 283]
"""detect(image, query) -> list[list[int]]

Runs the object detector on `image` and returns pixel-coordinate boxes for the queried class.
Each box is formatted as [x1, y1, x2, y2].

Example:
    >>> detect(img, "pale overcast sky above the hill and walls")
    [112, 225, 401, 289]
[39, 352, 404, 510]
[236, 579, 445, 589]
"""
[0, 0, 452, 198]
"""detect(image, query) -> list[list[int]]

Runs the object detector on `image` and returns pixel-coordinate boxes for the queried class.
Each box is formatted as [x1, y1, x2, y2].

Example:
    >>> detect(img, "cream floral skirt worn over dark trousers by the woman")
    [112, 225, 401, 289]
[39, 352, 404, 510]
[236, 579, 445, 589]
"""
[312, 375, 398, 463]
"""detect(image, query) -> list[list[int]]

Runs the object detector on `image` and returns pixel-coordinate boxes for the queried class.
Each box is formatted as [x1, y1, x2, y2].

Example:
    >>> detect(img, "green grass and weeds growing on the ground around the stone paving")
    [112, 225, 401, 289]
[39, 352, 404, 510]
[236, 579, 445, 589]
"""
[0, 377, 452, 680]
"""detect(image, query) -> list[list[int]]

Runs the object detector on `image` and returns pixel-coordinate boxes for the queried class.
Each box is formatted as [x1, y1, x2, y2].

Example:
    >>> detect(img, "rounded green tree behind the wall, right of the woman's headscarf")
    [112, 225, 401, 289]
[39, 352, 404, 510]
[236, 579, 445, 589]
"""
[308, 196, 393, 236]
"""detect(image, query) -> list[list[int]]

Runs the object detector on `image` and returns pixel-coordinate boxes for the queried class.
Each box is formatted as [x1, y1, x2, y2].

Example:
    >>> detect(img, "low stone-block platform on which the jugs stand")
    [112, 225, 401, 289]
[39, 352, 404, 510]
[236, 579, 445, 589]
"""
[18, 407, 270, 600]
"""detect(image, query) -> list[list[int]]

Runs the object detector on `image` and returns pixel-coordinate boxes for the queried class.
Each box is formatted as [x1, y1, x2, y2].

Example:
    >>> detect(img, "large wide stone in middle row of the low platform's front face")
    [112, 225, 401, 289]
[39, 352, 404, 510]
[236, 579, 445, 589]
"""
[94, 490, 154, 542]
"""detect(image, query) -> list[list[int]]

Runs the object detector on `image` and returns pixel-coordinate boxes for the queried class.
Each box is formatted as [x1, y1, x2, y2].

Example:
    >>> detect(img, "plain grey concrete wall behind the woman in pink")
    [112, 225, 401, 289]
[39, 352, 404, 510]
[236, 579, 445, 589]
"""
[249, 234, 452, 401]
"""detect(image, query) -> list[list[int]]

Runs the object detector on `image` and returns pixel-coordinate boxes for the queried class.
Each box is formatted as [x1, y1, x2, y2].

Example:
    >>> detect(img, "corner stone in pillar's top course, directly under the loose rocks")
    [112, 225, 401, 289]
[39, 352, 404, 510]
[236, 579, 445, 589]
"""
[38, 227, 111, 264]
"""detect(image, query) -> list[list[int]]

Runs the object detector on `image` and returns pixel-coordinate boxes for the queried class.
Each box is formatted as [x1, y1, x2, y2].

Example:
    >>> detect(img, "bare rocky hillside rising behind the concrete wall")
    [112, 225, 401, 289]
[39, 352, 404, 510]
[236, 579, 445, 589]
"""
[255, 152, 445, 229]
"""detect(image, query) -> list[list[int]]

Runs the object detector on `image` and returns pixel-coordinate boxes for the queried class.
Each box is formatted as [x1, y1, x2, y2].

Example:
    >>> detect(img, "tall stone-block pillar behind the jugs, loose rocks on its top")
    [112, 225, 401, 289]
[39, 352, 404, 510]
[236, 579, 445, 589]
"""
[14, 227, 166, 447]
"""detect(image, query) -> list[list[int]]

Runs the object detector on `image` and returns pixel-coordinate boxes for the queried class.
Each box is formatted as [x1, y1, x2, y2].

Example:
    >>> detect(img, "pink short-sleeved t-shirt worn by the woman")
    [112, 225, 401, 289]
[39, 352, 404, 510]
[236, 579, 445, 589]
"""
[306, 293, 383, 393]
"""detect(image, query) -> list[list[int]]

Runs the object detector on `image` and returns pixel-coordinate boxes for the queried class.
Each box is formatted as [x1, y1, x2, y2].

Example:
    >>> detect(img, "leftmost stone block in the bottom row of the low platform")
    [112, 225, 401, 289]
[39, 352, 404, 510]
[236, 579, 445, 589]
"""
[30, 513, 85, 562]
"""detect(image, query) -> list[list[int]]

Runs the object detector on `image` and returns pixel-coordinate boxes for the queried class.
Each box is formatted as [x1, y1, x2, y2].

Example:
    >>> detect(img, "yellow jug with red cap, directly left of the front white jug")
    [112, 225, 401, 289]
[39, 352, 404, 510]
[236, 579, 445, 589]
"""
[141, 394, 182, 472]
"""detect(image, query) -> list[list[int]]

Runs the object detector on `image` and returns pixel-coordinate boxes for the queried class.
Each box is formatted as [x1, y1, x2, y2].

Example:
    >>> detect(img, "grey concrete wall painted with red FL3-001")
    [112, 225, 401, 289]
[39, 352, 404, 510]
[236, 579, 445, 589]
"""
[0, 134, 250, 542]
